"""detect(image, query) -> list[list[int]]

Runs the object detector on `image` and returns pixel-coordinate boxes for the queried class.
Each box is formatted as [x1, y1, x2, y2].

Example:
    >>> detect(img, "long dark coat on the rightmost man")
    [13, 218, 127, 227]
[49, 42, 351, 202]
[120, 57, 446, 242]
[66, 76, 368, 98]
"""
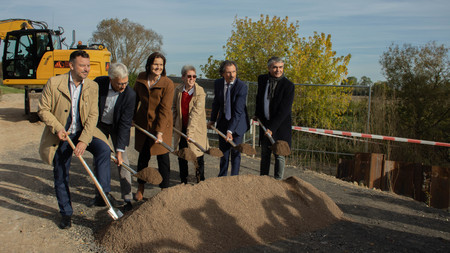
[255, 74, 295, 146]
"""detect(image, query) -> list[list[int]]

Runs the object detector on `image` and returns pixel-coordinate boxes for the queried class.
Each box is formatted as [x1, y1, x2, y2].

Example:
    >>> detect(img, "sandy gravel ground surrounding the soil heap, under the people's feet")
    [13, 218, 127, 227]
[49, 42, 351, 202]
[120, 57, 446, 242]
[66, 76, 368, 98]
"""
[0, 94, 450, 252]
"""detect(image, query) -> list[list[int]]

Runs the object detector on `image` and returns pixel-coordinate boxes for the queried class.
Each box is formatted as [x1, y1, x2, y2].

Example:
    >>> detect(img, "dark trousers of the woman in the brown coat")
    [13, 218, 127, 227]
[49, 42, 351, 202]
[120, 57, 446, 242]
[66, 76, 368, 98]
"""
[137, 138, 170, 188]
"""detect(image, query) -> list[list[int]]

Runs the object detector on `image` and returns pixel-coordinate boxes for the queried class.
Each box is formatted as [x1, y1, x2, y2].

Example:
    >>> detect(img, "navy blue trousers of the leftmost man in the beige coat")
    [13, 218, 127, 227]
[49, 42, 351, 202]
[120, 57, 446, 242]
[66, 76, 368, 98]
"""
[53, 132, 111, 216]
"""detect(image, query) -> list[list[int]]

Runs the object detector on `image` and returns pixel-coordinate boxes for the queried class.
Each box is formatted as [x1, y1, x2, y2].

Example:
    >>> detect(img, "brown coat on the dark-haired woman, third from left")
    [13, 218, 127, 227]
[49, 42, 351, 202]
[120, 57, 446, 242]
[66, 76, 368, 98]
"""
[134, 72, 175, 155]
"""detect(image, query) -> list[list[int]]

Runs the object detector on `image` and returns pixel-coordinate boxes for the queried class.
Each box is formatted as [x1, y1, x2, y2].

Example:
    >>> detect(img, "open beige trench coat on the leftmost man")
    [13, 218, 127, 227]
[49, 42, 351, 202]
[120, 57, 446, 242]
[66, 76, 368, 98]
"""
[38, 73, 109, 164]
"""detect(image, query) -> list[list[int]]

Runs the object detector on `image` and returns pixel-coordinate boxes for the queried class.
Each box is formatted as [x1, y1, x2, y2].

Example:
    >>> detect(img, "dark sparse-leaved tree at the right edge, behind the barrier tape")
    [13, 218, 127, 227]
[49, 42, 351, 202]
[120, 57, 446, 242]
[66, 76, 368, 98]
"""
[380, 42, 450, 165]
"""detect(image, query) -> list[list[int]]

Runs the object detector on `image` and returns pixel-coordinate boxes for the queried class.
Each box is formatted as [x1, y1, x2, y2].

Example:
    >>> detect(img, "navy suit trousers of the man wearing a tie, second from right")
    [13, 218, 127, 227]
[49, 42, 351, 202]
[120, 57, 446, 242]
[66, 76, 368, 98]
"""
[219, 134, 243, 177]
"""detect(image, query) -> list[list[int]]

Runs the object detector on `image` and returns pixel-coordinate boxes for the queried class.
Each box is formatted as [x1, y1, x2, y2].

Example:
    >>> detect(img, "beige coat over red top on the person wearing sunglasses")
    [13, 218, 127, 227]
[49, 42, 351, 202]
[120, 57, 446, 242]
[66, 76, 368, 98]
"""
[172, 83, 209, 157]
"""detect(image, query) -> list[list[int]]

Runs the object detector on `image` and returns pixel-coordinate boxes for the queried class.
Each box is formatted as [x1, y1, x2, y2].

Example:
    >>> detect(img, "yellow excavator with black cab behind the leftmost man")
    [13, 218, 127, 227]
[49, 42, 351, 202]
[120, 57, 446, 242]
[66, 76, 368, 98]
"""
[0, 19, 111, 114]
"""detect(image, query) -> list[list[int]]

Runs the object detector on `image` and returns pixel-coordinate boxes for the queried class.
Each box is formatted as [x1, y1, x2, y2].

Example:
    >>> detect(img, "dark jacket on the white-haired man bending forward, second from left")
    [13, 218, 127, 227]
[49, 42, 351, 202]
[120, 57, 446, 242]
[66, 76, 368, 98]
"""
[94, 76, 136, 150]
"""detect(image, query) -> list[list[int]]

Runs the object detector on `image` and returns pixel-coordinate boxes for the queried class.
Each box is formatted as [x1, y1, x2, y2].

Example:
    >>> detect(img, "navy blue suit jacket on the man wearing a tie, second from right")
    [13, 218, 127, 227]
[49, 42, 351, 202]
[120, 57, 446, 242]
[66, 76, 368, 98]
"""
[211, 78, 250, 135]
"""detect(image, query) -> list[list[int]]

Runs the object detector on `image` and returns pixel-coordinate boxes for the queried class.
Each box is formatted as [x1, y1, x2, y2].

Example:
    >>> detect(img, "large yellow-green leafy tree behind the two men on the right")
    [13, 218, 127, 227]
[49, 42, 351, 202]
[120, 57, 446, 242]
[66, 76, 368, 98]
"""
[201, 15, 351, 127]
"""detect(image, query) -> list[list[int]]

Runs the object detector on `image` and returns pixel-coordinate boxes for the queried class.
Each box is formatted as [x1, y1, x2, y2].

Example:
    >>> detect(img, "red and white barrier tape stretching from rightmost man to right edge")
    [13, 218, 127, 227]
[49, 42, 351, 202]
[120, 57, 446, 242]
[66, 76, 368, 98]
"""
[292, 126, 450, 148]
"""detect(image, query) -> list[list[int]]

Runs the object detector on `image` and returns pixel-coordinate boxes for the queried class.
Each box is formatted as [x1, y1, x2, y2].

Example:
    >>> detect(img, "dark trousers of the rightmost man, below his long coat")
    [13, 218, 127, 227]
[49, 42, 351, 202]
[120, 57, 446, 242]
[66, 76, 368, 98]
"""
[260, 137, 286, 179]
